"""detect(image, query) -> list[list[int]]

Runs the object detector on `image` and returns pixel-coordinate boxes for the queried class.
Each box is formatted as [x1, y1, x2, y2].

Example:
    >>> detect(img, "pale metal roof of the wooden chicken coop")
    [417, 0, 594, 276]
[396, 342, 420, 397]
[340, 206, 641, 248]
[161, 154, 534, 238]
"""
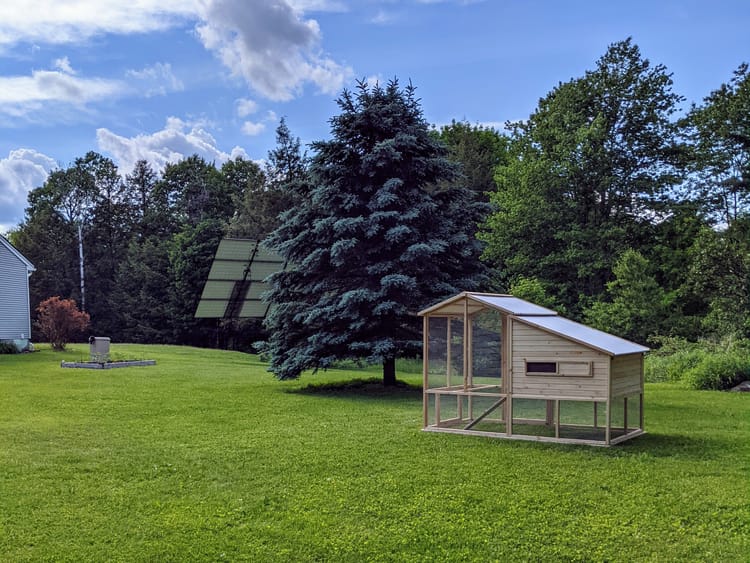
[419, 291, 648, 356]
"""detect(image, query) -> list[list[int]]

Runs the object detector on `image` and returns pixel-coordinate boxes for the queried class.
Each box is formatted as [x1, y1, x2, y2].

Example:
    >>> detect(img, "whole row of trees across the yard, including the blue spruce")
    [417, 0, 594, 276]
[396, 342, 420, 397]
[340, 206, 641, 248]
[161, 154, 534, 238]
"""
[11, 39, 750, 377]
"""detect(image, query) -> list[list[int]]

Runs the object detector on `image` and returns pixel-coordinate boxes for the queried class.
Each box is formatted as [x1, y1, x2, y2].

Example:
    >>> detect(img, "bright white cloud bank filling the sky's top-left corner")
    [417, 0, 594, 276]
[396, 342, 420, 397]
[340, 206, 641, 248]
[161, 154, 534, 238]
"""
[0, 0, 199, 45]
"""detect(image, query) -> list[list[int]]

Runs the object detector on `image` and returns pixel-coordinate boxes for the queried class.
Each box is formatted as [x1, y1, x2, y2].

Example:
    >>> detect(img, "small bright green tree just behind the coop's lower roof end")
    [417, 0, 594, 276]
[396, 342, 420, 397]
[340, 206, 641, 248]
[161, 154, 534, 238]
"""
[584, 249, 672, 343]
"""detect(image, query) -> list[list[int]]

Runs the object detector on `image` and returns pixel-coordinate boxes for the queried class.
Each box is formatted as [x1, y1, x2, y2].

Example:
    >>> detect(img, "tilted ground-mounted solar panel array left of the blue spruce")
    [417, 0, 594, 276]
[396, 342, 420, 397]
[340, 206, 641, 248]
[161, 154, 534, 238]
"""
[195, 239, 286, 319]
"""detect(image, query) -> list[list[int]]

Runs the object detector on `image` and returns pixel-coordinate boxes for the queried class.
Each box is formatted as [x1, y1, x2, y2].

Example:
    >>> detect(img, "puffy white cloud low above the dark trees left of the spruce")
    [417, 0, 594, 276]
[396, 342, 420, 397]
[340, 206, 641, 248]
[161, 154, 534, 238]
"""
[96, 117, 248, 174]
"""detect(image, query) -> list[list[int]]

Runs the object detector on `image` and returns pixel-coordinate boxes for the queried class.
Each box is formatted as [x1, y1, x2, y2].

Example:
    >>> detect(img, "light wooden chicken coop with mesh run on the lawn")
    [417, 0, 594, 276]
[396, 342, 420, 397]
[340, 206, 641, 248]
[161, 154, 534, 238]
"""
[419, 292, 648, 446]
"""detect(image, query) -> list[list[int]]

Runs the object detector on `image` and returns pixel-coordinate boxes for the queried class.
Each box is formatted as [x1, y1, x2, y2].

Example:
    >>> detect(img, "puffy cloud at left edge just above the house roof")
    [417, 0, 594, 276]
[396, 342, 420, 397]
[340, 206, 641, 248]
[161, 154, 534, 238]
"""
[0, 148, 57, 232]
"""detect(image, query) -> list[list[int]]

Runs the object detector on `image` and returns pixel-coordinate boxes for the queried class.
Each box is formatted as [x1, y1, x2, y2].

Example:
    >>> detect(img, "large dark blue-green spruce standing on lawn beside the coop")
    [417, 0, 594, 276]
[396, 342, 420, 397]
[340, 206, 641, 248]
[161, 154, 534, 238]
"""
[266, 80, 482, 384]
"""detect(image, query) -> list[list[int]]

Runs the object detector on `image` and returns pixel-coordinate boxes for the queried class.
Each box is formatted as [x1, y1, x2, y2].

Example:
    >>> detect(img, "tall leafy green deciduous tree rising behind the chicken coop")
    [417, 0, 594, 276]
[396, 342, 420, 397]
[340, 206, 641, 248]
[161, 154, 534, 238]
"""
[480, 39, 681, 316]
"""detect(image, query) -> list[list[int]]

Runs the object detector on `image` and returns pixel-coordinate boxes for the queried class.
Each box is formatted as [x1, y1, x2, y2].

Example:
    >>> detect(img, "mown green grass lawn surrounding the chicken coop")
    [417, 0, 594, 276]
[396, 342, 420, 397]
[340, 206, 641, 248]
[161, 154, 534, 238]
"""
[0, 345, 750, 561]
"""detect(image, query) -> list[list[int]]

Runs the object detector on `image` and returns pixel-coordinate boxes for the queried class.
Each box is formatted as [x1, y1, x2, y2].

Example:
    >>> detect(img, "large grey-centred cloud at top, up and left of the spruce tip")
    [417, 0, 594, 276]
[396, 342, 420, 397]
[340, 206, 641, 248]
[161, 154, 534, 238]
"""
[197, 0, 352, 101]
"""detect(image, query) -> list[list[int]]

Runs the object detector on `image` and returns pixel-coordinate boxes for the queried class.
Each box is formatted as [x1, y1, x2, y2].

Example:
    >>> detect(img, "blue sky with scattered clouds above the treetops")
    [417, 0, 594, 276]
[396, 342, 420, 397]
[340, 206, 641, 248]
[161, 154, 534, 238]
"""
[0, 0, 750, 232]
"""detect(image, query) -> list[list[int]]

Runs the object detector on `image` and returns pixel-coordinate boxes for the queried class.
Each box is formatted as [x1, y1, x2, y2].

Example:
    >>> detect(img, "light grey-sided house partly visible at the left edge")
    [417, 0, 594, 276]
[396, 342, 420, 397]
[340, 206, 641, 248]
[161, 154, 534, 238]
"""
[0, 236, 34, 350]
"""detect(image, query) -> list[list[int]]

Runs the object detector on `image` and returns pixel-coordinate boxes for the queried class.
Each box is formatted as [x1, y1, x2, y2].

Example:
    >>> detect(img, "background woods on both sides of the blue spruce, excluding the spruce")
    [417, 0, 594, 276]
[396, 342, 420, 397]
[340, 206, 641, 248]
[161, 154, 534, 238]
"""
[9, 40, 750, 366]
